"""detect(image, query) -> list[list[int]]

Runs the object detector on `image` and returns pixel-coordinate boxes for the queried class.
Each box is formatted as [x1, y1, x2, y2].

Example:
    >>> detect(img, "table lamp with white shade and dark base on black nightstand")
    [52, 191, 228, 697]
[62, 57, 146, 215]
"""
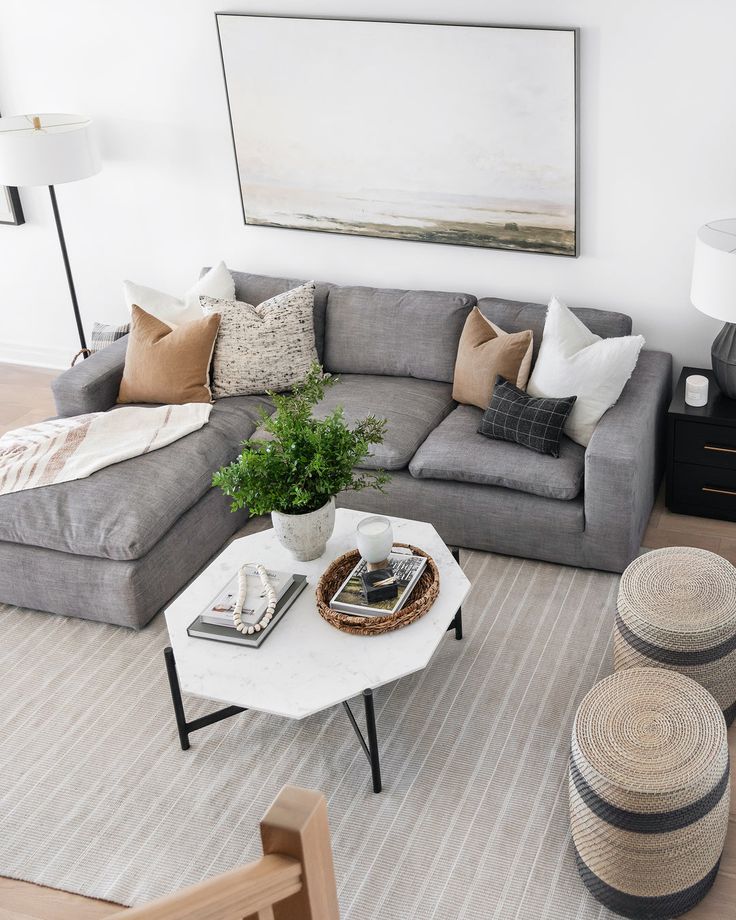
[690, 218, 736, 399]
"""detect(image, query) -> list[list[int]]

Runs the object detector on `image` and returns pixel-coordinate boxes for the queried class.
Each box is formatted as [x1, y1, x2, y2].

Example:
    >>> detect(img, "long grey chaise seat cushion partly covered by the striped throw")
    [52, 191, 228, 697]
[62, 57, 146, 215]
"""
[0, 396, 271, 560]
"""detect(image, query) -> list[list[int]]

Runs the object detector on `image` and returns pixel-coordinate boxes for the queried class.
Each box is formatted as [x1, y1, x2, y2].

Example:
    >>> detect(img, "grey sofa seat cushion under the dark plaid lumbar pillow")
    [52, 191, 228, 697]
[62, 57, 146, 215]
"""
[409, 406, 585, 501]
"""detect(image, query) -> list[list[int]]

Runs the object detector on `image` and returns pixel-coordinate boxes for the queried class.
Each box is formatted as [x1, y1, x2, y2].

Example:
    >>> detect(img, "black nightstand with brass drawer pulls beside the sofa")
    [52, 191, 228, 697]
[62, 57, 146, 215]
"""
[666, 367, 736, 521]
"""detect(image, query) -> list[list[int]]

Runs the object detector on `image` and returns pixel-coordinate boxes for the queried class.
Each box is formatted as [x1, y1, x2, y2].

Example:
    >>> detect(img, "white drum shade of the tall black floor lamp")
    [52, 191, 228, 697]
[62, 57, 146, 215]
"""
[0, 114, 101, 186]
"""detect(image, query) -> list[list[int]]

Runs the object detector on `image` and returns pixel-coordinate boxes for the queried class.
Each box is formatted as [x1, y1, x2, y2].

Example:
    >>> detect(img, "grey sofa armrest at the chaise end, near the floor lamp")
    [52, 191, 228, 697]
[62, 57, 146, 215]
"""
[51, 335, 128, 416]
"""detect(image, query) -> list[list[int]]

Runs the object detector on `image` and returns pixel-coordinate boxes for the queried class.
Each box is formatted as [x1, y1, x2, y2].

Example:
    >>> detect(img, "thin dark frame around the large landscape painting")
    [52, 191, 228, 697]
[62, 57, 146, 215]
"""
[215, 11, 580, 259]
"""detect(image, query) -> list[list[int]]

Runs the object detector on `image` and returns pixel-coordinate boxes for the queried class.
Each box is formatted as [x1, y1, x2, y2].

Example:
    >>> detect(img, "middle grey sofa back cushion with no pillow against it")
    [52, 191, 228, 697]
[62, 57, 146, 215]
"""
[324, 285, 476, 383]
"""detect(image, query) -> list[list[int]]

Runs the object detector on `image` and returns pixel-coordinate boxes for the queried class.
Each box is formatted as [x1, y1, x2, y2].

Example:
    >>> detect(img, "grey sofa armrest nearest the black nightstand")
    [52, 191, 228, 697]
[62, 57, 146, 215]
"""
[585, 351, 672, 571]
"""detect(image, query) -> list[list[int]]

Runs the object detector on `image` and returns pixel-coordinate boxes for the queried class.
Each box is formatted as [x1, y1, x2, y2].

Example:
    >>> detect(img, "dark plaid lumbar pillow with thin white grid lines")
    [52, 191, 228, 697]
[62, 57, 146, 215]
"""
[478, 376, 577, 457]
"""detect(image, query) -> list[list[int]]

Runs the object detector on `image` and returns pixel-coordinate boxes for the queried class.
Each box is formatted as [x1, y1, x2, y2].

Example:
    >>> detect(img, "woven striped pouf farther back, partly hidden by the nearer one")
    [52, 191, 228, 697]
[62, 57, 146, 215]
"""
[613, 546, 736, 725]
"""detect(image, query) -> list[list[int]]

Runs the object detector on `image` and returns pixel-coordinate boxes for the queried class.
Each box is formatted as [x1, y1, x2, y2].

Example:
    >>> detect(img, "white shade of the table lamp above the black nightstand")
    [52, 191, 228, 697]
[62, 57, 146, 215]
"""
[690, 218, 736, 323]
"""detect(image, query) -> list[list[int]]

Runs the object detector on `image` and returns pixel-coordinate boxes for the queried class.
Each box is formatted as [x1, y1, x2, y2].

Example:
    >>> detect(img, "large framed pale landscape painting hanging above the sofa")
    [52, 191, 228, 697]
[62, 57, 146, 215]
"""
[217, 13, 578, 256]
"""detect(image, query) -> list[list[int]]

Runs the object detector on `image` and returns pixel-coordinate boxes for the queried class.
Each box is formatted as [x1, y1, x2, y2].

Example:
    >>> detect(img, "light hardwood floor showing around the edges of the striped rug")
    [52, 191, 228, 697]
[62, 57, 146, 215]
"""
[0, 364, 736, 920]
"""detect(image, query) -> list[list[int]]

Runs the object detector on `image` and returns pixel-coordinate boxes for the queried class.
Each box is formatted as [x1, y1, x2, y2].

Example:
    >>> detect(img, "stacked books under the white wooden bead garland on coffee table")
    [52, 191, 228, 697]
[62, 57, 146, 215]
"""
[187, 566, 307, 648]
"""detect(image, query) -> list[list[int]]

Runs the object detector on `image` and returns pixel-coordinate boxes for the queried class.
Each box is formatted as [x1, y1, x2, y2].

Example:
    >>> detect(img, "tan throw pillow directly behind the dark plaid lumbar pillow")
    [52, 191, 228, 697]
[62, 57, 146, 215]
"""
[452, 307, 532, 409]
